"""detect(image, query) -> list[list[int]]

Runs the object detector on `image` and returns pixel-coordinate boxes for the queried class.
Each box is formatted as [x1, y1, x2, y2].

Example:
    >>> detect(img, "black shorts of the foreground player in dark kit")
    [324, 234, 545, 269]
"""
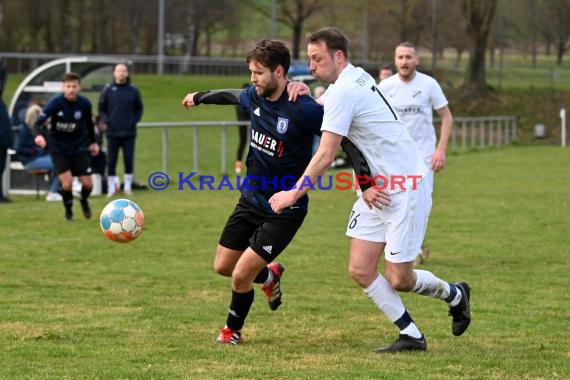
[220, 197, 306, 263]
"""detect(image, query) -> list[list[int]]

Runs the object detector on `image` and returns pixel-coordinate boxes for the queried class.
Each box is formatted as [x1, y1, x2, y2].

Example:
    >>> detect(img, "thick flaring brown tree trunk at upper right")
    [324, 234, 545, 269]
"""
[463, 0, 497, 94]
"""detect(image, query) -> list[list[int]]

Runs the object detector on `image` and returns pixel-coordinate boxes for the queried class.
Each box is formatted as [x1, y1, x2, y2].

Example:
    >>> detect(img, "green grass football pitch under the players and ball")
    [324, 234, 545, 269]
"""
[0, 70, 570, 380]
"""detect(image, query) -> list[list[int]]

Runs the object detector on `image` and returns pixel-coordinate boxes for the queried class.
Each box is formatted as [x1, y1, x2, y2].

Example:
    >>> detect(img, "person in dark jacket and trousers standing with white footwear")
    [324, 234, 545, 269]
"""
[99, 63, 143, 197]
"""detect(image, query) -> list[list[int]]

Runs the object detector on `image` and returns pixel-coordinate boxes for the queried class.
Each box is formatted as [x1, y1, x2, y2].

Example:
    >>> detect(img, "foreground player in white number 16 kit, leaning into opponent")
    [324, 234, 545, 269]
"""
[269, 27, 471, 353]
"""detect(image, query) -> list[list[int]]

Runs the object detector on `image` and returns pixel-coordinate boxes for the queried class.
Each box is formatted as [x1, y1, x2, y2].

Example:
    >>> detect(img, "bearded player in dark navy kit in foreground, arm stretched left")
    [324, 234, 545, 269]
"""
[182, 40, 323, 344]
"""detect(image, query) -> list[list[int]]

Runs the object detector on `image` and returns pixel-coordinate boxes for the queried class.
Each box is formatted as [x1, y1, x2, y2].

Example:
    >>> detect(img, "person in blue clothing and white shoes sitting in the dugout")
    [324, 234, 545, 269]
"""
[15, 104, 62, 202]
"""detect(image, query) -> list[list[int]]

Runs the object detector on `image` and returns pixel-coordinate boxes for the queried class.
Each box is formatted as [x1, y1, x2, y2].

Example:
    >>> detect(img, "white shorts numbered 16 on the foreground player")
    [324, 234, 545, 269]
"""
[346, 180, 431, 263]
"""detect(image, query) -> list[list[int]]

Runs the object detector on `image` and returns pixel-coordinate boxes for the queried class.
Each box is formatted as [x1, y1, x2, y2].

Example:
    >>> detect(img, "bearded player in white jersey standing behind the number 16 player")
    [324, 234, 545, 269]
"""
[378, 42, 453, 264]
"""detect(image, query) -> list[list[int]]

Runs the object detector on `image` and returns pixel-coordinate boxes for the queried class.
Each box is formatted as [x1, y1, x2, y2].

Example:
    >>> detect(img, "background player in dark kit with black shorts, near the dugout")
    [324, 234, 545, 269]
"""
[34, 72, 99, 220]
